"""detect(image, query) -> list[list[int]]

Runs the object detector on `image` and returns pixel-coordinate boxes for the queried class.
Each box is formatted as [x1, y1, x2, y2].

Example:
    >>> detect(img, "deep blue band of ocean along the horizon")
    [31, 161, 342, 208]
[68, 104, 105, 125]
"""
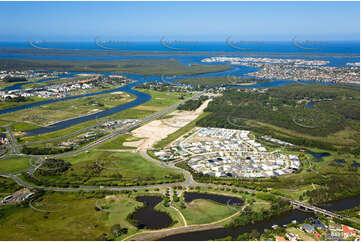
[0, 40, 360, 55]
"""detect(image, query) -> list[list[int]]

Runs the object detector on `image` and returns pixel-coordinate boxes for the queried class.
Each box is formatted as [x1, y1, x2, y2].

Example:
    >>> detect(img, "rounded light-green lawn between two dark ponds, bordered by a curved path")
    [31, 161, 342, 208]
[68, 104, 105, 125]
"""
[178, 199, 236, 225]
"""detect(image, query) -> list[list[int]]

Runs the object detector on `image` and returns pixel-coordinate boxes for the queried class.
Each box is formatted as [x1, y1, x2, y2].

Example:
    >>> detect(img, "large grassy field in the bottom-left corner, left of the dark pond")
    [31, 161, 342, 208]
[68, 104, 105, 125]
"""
[0, 192, 141, 241]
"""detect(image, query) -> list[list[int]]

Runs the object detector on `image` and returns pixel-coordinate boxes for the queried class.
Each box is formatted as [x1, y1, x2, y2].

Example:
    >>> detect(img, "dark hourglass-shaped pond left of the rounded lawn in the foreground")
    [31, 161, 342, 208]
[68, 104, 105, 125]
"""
[130, 196, 173, 229]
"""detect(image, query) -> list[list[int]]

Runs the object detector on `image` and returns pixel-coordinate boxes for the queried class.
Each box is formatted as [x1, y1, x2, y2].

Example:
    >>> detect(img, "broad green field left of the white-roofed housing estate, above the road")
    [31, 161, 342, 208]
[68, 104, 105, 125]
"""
[30, 150, 183, 186]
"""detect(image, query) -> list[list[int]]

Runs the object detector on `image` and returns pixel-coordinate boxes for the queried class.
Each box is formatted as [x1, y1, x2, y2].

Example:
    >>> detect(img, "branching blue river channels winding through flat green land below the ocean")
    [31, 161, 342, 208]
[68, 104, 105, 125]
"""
[0, 57, 358, 136]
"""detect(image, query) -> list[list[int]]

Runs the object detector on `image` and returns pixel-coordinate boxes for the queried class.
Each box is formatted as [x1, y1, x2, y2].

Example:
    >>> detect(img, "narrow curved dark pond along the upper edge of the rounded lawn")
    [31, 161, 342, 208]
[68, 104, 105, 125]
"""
[184, 192, 243, 206]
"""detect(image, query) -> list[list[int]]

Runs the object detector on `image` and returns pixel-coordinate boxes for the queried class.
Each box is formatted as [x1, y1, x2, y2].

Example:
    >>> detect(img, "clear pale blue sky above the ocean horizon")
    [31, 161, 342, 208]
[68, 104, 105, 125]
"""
[0, 2, 360, 41]
